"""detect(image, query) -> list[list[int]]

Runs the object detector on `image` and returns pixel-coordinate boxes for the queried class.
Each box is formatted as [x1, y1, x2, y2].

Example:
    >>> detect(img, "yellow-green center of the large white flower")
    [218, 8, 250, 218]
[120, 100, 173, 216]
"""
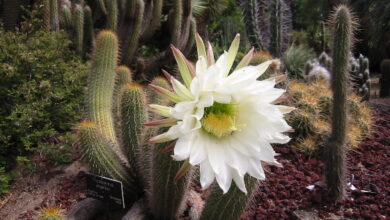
[200, 102, 238, 138]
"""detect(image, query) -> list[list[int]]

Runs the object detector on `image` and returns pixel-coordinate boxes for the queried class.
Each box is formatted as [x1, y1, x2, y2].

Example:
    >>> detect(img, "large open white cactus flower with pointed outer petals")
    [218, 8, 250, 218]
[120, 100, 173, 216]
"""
[146, 35, 294, 193]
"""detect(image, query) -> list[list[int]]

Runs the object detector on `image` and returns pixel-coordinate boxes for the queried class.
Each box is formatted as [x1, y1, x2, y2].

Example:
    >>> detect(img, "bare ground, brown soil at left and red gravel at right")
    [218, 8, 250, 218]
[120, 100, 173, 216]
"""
[0, 99, 390, 220]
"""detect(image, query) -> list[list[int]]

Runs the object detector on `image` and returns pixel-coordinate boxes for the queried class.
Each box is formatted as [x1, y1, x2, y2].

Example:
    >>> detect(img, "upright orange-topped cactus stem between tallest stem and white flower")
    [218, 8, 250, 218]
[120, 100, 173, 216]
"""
[121, 83, 150, 185]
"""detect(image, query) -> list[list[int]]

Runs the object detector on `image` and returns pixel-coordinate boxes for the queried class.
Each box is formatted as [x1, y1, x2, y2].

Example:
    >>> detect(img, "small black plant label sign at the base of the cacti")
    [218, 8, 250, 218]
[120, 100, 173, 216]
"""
[86, 173, 125, 209]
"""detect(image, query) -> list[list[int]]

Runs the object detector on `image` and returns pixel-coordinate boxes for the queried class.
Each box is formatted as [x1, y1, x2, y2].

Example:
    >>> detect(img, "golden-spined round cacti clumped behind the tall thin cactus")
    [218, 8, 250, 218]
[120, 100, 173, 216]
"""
[287, 78, 372, 154]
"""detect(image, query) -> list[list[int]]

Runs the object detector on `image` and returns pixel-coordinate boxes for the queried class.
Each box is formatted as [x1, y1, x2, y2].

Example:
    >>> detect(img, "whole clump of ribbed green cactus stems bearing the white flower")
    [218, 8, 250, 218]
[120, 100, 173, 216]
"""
[77, 30, 256, 219]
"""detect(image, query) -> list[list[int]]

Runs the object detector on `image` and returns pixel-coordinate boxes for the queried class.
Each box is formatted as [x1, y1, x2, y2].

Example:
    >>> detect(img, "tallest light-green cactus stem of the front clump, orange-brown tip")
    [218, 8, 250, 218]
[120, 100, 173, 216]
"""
[86, 31, 118, 143]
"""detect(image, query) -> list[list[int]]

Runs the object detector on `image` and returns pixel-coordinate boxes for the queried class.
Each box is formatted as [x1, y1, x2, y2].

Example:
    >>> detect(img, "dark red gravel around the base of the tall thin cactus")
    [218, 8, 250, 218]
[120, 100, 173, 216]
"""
[243, 111, 390, 219]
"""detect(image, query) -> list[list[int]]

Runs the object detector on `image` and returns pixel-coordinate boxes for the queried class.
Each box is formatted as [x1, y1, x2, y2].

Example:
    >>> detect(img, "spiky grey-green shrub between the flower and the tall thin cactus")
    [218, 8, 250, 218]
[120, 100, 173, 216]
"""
[283, 44, 315, 79]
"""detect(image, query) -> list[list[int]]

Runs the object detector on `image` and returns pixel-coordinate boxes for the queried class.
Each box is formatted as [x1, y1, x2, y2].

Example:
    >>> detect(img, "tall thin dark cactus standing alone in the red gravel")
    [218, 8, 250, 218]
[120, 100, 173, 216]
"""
[326, 5, 354, 199]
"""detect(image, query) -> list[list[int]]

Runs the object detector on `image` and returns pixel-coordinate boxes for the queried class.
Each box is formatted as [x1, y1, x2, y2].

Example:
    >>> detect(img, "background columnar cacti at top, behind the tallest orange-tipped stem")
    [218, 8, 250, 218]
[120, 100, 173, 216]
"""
[50, 0, 196, 75]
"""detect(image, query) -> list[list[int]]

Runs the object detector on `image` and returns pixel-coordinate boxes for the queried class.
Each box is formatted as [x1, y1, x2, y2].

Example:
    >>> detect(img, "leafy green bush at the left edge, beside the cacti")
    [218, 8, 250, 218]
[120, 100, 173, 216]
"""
[0, 29, 87, 169]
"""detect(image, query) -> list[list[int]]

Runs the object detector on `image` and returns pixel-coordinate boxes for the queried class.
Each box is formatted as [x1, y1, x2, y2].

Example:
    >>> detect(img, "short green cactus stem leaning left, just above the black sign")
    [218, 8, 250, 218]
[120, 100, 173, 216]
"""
[77, 121, 138, 194]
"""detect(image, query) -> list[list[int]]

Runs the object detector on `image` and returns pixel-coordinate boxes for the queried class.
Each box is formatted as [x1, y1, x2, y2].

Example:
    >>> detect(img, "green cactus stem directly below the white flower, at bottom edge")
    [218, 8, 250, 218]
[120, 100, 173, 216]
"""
[200, 176, 258, 220]
